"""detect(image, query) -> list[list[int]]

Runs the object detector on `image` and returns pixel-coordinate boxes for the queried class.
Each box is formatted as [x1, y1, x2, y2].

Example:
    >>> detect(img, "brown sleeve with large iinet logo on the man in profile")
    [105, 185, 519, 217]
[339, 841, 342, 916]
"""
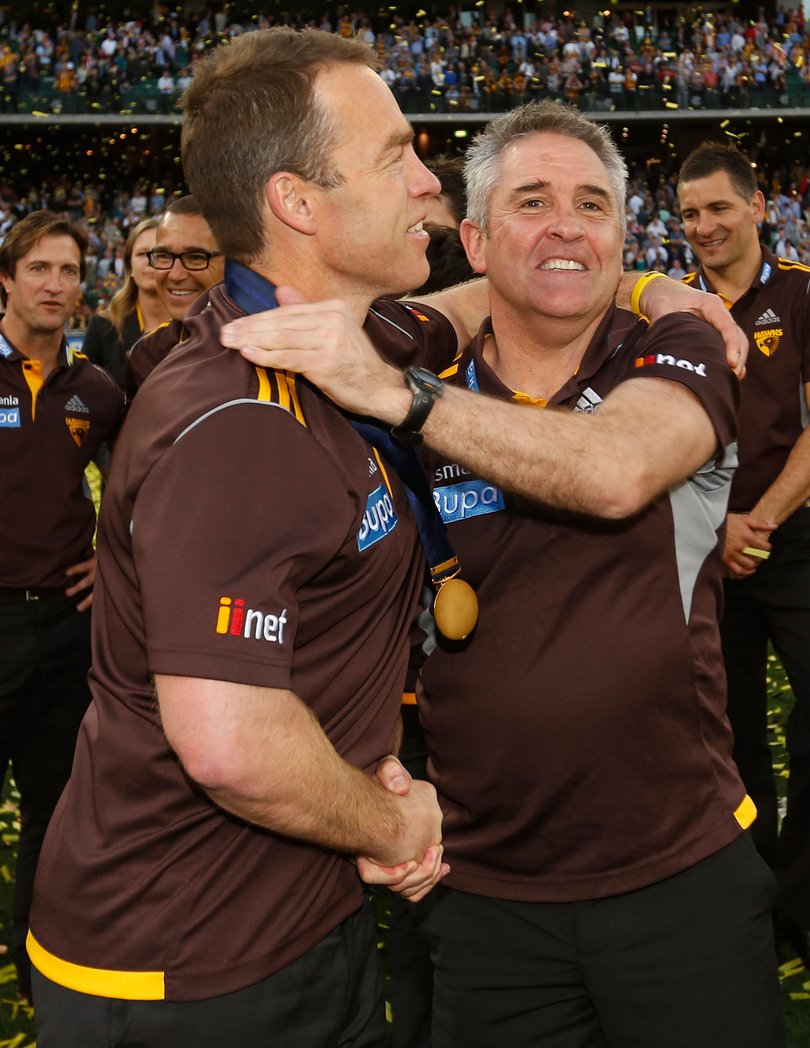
[131, 400, 354, 689]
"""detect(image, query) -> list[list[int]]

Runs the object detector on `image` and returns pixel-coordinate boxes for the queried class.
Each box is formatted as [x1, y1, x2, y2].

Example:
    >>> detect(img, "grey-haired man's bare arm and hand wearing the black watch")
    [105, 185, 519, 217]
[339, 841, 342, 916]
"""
[223, 302, 717, 518]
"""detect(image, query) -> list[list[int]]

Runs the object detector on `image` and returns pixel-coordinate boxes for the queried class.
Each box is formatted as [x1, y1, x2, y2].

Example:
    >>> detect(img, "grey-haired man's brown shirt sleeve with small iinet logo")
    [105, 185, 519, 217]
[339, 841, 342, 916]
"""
[627, 312, 740, 454]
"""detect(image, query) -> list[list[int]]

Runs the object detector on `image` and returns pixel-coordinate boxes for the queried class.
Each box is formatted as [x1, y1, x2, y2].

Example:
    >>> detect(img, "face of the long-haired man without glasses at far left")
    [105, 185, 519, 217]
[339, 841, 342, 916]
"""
[0, 235, 82, 341]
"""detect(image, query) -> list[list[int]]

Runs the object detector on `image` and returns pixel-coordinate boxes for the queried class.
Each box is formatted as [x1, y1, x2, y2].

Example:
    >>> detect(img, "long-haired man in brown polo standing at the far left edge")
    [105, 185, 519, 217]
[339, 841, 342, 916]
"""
[0, 212, 123, 997]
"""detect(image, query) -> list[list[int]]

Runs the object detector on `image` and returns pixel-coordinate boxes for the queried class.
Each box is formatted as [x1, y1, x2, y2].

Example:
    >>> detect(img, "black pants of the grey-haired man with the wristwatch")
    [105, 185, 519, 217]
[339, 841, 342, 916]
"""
[417, 834, 785, 1048]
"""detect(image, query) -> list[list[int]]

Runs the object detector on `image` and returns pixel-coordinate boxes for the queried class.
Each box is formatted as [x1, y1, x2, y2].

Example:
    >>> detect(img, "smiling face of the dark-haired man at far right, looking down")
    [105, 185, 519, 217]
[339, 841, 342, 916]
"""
[678, 171, 765, 274]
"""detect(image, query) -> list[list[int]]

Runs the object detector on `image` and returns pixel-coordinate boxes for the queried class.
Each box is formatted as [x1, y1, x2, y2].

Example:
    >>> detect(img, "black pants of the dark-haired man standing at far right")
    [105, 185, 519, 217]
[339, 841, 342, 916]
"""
[721, 508, 810, 895]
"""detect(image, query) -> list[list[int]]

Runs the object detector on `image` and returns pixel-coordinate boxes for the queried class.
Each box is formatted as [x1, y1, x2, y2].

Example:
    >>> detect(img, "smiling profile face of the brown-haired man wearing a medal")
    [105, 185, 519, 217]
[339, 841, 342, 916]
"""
[305, 64, 439, 308]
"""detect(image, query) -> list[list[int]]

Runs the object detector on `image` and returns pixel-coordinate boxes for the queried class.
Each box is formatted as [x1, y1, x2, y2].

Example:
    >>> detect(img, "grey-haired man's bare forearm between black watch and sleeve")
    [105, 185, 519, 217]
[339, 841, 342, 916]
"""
[410, 379, 716, 519]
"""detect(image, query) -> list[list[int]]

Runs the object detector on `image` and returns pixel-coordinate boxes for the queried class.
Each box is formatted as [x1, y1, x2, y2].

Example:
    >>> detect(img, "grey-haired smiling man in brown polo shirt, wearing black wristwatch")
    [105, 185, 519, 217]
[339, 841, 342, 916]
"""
[225, 103, 784, 1048]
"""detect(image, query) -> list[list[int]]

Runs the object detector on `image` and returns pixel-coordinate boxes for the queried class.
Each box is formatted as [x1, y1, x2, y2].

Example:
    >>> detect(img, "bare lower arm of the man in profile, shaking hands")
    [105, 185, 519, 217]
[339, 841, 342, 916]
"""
[155, 675, 441, 866]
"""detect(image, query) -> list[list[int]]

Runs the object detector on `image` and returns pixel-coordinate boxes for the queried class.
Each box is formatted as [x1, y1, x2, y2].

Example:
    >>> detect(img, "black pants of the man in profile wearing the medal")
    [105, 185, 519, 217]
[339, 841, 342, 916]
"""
[34, 903, 385, 1048]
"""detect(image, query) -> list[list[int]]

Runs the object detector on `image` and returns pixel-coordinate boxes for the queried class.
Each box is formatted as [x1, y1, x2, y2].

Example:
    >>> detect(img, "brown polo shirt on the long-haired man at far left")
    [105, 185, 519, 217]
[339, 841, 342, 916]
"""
[0, 335, 124, 589]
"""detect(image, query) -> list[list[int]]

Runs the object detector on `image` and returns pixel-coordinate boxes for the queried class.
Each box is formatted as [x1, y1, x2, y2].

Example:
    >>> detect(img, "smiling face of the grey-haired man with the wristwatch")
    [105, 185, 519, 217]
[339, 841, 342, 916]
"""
[461, 132, 622, 326]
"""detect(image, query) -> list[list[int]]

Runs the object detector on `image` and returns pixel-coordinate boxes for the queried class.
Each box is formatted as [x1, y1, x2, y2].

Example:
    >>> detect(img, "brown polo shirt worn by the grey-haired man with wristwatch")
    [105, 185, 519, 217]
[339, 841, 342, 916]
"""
[419, 310, 750, 901]
